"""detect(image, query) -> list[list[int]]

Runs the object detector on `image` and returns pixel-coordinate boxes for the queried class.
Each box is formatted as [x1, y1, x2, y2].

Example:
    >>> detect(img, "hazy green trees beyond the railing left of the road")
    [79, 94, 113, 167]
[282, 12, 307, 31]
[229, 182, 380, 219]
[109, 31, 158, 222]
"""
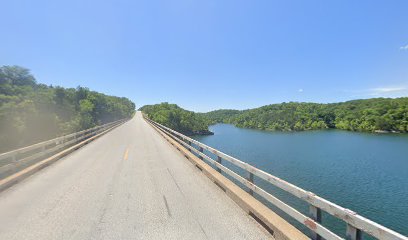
[0, 66, 135, 152]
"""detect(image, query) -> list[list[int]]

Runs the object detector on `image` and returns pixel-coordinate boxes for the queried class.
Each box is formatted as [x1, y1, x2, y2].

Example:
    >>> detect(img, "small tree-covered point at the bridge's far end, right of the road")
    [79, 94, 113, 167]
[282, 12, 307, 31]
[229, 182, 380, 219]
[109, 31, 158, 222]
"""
[140, 103, 212, 135]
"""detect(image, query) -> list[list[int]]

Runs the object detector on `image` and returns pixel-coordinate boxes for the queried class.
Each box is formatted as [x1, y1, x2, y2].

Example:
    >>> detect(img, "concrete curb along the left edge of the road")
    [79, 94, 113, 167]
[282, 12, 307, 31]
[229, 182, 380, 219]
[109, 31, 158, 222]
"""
[0, 121, 127, 192]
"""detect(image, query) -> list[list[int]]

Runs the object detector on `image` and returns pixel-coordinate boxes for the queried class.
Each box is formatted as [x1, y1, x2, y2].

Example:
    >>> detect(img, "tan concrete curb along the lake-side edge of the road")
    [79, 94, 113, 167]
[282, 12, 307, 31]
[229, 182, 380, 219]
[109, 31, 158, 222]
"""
[146, 121, 310, 240]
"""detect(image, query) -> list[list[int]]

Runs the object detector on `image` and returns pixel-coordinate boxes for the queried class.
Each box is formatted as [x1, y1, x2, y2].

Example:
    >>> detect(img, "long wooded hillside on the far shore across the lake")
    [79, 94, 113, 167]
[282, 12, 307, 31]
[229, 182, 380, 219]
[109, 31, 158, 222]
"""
[203, 98, 408, 133]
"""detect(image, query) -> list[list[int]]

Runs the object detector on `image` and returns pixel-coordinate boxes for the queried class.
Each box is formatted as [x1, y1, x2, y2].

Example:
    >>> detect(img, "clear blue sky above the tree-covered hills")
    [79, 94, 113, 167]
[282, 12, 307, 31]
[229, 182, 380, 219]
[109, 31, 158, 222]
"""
[0, 0, 408, 111]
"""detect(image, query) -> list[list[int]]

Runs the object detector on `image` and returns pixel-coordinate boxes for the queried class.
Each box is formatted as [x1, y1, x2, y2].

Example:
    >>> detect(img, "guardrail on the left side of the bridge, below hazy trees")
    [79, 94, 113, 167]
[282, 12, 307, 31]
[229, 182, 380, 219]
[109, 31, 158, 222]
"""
[0, 119, 127, 179]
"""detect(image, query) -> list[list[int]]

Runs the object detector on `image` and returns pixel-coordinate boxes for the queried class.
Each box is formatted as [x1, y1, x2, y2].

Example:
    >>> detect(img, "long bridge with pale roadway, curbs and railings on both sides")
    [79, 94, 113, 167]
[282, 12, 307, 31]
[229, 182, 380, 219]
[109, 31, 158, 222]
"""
[0, 112, 408, 240]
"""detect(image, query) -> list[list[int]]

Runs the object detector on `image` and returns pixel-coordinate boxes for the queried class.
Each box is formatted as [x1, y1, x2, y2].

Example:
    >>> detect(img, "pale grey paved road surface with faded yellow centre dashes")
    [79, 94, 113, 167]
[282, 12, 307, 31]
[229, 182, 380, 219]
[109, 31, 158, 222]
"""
[0, 113, 270, 240]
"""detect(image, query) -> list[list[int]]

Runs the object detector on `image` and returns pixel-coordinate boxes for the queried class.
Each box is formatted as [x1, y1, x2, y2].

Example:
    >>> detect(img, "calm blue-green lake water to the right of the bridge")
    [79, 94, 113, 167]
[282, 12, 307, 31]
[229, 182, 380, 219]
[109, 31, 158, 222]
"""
[195, 124, 408, 238]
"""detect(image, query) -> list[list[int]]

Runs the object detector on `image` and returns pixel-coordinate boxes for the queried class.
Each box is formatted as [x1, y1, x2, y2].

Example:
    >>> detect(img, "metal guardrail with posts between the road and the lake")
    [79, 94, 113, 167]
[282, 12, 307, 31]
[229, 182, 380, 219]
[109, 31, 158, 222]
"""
[145, 118, 408, 240]
